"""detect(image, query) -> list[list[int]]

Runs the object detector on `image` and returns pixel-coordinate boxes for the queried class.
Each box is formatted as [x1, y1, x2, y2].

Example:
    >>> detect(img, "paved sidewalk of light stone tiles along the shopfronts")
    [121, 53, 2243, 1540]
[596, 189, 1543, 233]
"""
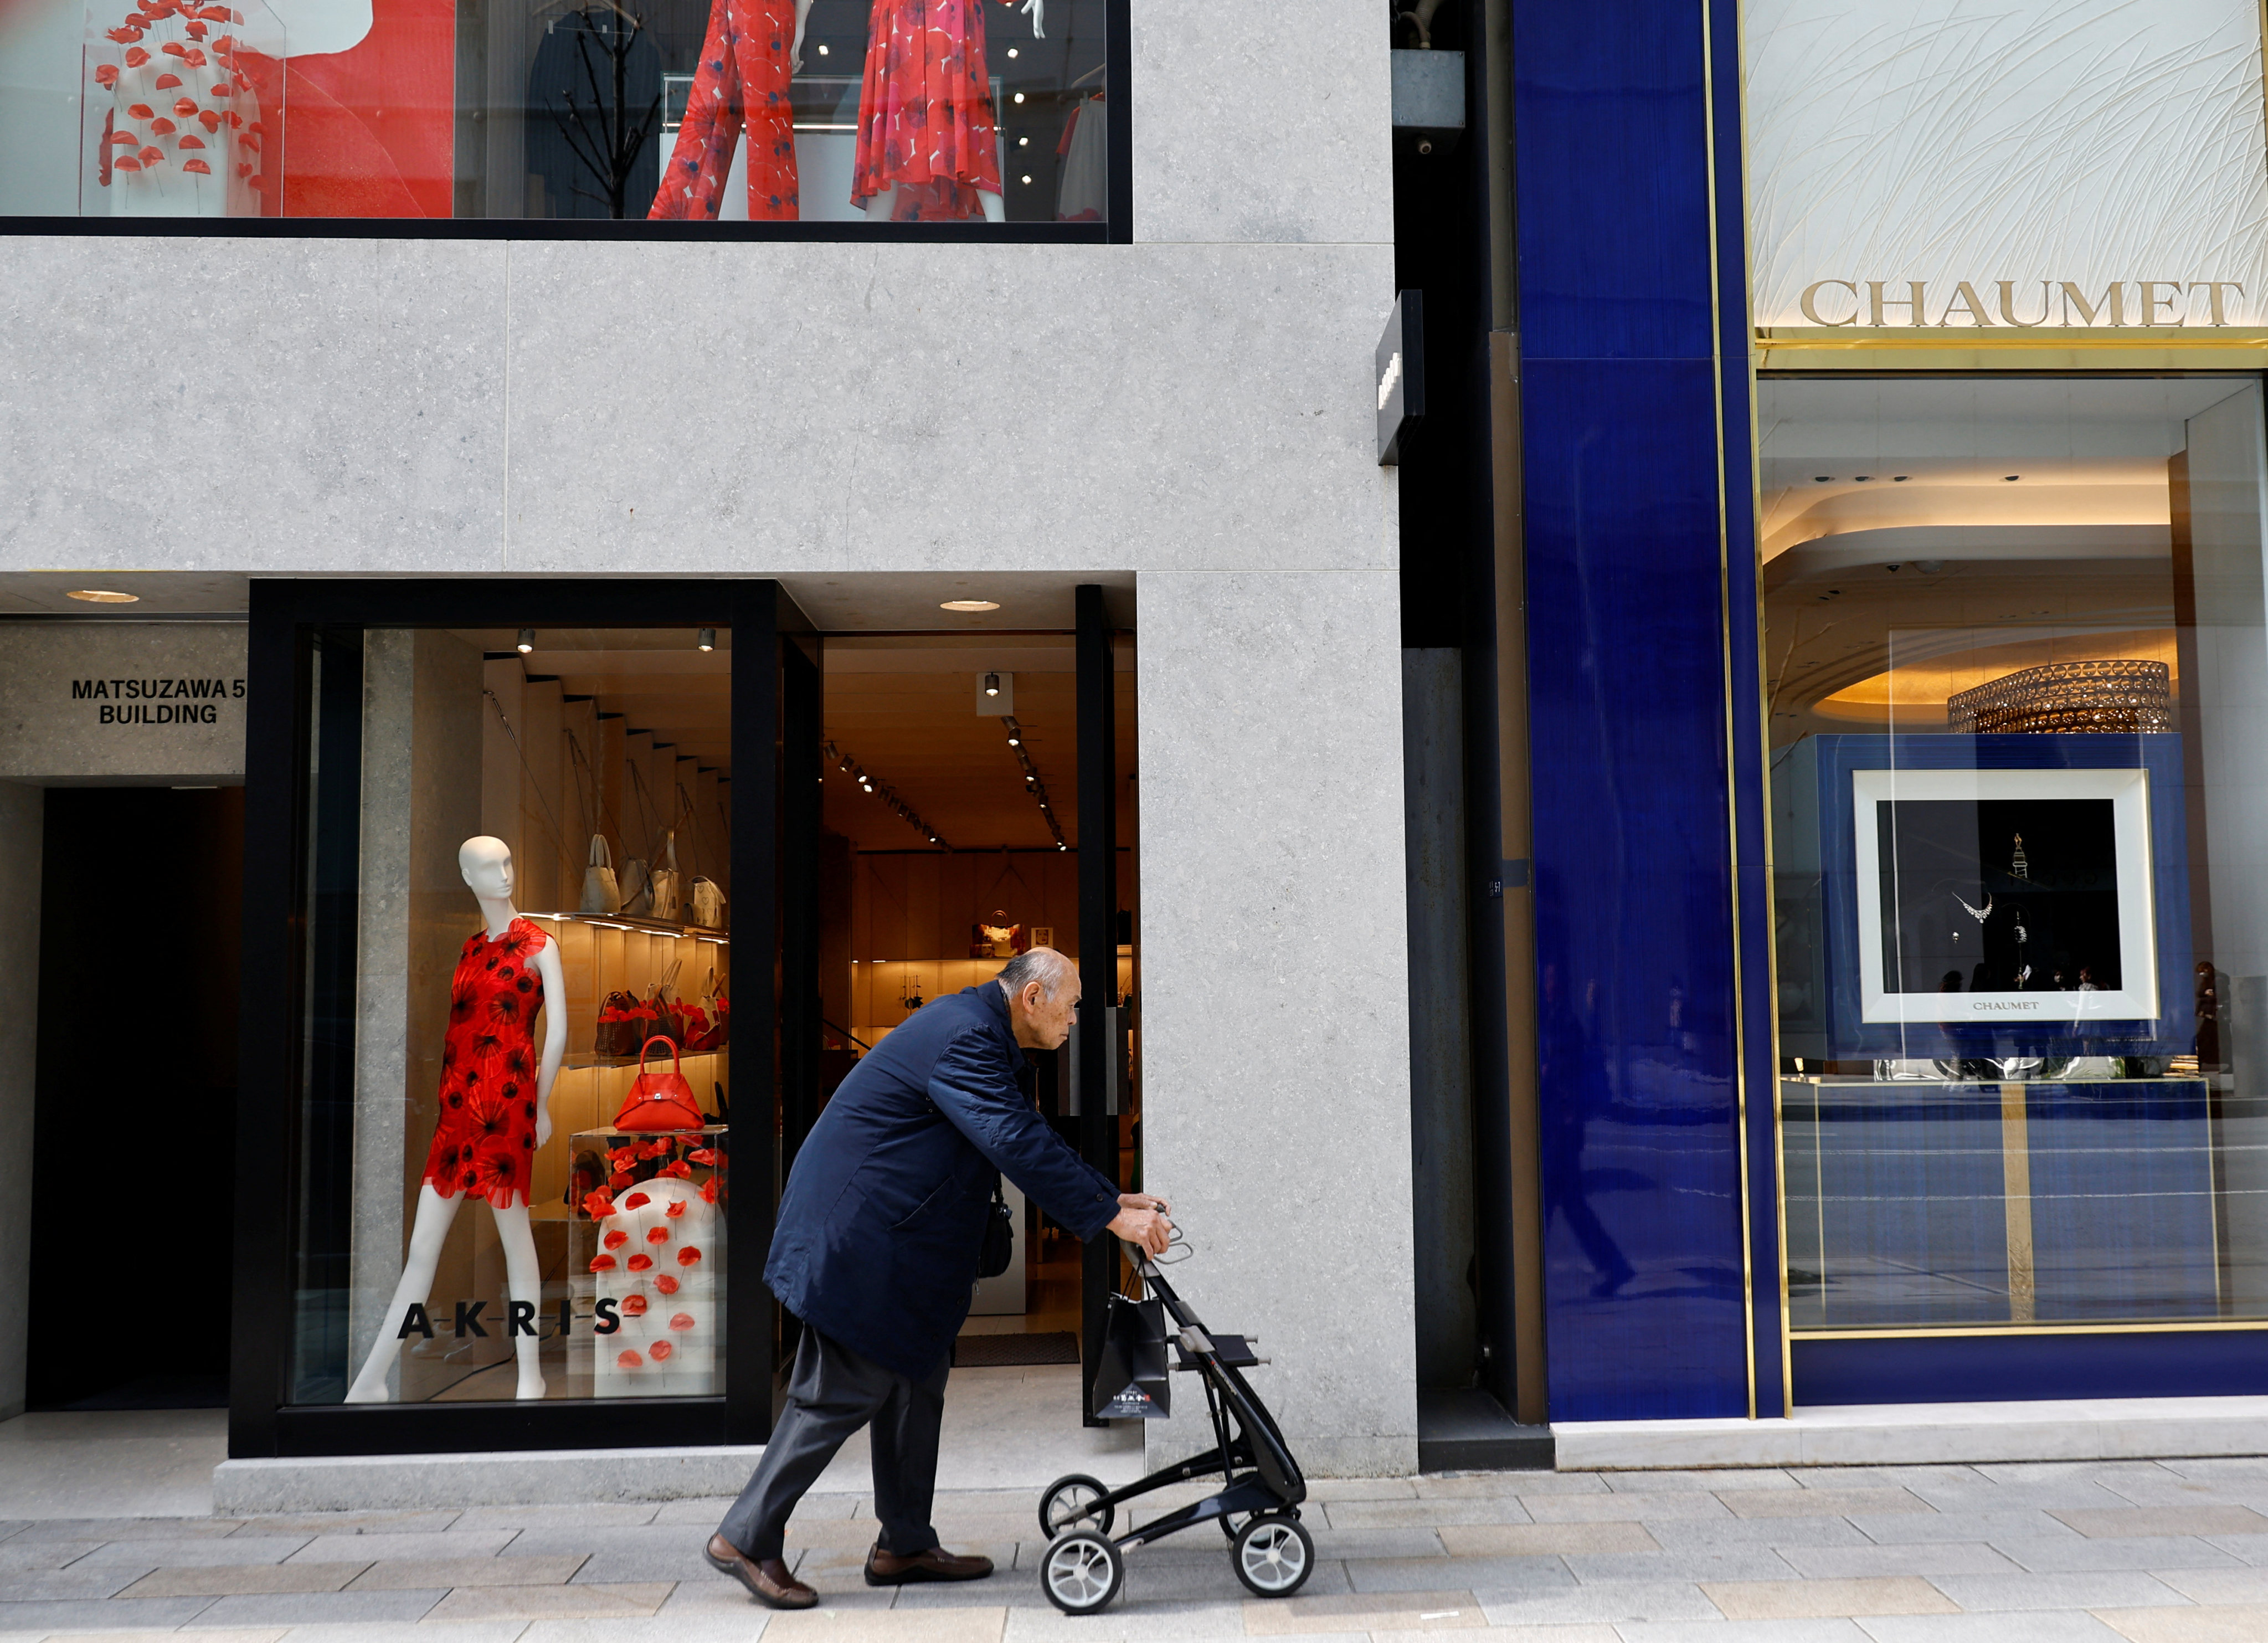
[0, 1459, 2268, 1643]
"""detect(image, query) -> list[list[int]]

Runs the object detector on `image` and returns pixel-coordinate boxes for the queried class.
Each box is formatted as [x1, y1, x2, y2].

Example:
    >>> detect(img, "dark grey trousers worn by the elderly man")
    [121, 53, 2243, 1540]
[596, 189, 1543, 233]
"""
[717, 1323, 953, 1559]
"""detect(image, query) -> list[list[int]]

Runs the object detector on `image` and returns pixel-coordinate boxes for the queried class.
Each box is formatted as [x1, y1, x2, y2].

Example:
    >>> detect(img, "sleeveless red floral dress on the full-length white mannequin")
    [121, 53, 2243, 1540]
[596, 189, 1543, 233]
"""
[424, 919, 551, 1210]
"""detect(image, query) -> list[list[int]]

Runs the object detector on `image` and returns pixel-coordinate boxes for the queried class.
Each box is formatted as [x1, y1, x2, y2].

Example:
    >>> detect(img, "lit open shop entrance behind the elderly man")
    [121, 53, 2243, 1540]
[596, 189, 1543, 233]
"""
[783, 608, 1141, 1425]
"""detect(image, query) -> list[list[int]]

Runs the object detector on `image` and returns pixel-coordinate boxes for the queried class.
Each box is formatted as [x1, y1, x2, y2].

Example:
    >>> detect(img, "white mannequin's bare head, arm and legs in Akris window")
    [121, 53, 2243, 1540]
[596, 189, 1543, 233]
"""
[347, 835, 567, 1403]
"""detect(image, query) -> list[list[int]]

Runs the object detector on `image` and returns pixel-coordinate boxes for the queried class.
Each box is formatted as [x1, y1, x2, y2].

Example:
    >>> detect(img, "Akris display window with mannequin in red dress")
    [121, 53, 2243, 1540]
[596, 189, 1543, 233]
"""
[286, 629, 726, 1405]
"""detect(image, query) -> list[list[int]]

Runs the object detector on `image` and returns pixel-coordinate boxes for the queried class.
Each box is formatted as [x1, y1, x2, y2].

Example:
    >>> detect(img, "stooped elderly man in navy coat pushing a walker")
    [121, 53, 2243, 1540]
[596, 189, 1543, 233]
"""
[706, 946, 1172, 1609]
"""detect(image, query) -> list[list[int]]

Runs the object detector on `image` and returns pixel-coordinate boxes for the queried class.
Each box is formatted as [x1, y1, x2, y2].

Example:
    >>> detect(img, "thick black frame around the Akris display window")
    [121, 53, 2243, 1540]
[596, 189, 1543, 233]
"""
[229, 577, 816, 1459]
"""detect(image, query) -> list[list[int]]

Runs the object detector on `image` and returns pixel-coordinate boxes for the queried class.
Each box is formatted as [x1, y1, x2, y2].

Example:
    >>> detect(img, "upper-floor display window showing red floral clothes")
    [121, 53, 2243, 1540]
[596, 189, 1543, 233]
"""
[0, 0, 1112, 229]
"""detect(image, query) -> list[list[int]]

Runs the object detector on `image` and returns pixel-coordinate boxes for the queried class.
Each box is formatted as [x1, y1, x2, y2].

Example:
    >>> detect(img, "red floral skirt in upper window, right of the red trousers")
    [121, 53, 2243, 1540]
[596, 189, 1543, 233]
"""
[851, 0, 1000, 222]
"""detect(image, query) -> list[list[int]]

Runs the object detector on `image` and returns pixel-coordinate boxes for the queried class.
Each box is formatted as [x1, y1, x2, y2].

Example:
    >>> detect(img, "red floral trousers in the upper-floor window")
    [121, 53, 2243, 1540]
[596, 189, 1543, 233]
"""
[646, 0, 798, 222]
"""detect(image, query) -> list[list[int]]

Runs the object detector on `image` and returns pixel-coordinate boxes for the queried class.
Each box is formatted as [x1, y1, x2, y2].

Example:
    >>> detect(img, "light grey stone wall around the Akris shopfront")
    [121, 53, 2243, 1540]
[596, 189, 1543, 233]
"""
[0, 0, 1415, 1471]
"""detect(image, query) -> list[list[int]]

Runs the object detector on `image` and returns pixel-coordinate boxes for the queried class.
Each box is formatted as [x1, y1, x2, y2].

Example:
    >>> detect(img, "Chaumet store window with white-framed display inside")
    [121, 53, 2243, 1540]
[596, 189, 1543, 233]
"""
[1758, 374, 2268, 1339]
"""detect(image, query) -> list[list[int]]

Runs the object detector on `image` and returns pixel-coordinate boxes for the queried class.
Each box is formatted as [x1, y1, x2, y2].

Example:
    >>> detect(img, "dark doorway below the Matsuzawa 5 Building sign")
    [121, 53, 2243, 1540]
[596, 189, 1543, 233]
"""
[27, 788, 245, 1409]
